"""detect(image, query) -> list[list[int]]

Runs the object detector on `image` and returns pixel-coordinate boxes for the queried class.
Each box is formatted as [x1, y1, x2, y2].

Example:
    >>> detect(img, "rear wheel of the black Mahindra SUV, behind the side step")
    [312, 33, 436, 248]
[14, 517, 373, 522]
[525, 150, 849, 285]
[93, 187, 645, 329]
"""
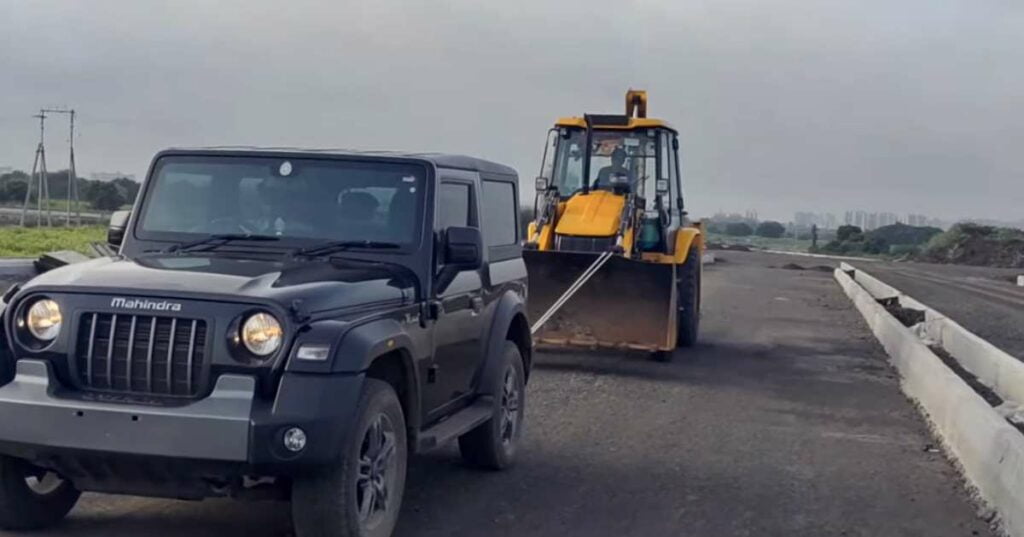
[459, 341, 526, 470]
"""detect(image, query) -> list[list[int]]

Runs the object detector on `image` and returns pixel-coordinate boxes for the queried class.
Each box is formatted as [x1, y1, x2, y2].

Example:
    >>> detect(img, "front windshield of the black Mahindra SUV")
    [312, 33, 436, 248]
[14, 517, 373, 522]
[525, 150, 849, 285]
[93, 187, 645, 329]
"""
[138, 157, 426, 246]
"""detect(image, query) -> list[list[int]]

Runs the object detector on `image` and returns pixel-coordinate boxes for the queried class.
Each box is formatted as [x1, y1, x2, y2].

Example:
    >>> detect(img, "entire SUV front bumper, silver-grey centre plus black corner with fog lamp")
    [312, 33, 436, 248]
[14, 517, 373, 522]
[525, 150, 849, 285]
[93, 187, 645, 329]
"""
[0, 359, 365, 475]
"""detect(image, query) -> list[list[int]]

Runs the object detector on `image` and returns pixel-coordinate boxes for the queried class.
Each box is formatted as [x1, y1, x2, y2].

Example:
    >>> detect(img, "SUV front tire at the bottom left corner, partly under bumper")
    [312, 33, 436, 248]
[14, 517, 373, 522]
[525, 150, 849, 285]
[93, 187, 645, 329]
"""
[0, 457, 82, 531]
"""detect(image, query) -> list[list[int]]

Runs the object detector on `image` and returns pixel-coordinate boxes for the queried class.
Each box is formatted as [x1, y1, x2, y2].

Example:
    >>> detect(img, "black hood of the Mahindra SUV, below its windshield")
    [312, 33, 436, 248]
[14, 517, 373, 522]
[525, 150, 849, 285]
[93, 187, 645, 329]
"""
[24, 254, 416, 314]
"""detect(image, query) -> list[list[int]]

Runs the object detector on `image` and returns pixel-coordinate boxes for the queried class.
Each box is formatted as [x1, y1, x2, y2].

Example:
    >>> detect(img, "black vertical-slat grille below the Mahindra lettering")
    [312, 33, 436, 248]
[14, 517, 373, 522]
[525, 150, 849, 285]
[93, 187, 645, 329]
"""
[76, 314, 208, 397]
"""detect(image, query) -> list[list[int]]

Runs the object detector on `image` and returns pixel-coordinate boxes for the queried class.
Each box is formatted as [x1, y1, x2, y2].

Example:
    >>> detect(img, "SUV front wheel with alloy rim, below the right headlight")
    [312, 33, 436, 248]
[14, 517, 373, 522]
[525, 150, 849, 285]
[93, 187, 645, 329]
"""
[292, 378, 409, 537]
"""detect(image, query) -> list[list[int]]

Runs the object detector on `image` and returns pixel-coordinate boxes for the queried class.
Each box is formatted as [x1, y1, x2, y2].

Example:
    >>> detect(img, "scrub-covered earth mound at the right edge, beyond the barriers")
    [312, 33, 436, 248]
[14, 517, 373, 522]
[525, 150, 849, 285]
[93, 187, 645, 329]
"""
[920, 222, 1024, 269]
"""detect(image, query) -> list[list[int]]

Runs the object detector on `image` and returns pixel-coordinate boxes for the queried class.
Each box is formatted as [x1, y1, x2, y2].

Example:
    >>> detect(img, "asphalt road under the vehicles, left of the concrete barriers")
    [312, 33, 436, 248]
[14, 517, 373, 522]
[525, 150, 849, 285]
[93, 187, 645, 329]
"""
[0, 252, 991, 537]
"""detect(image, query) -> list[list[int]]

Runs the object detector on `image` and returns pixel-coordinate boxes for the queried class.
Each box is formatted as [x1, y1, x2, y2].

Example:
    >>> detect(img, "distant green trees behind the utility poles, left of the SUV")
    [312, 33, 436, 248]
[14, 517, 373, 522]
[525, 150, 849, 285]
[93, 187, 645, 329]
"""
[0, 170, 139, 211]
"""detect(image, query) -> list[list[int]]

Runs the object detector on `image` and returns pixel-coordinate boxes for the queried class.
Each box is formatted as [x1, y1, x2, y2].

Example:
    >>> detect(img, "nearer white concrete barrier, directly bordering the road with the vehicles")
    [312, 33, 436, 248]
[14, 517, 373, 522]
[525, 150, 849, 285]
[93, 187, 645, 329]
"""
[835, 269, 1024, 537]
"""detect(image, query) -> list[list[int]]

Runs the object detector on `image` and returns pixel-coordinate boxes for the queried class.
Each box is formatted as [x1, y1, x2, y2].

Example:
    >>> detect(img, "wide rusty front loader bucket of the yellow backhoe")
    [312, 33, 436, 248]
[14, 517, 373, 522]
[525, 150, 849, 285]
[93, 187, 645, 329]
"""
[523, 250, 677, 352]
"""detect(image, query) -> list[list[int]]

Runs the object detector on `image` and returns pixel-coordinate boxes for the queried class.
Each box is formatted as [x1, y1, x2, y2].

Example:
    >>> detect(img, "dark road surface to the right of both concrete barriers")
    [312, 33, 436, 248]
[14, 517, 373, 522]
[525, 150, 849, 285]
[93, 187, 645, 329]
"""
[853, 261, 1024, 360]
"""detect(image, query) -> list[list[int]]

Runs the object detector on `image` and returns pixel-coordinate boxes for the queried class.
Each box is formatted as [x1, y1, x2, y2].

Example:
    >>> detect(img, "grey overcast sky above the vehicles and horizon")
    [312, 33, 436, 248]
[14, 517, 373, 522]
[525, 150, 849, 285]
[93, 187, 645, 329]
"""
[0, 0, 1024, 219]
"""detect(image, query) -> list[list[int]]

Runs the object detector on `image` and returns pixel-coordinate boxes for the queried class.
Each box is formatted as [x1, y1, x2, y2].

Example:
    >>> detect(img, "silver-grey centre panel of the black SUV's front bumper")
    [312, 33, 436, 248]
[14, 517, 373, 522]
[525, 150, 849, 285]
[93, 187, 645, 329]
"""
[0, 360, 256, 462]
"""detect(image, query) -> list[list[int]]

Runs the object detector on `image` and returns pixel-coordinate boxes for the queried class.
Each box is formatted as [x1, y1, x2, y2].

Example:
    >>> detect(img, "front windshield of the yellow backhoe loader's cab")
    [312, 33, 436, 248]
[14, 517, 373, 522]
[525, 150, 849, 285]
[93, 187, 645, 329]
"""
[552, 129, 657, 197]
